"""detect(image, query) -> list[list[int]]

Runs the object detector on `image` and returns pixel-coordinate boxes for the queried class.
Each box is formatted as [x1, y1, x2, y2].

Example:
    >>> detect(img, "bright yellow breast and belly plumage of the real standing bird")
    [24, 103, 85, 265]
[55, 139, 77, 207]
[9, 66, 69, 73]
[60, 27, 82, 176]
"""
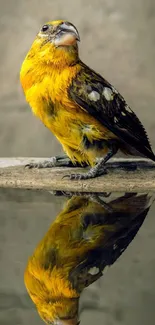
[20, 21, 115, 165]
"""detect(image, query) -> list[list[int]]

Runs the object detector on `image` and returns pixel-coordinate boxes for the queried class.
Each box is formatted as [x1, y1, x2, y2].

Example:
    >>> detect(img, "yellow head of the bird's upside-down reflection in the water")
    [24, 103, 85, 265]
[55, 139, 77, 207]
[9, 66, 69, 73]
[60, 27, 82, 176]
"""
[37, 298, 80, 325]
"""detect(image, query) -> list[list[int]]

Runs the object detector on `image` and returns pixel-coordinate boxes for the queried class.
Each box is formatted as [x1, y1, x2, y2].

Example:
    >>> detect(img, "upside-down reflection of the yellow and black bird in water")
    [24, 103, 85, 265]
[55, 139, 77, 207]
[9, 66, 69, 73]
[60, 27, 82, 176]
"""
[25, 194, 153, 325]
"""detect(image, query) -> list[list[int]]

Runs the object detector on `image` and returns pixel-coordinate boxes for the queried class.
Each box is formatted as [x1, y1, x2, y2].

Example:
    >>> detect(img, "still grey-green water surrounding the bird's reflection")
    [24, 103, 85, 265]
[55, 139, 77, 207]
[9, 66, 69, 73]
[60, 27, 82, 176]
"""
[0, 189, 155, 325]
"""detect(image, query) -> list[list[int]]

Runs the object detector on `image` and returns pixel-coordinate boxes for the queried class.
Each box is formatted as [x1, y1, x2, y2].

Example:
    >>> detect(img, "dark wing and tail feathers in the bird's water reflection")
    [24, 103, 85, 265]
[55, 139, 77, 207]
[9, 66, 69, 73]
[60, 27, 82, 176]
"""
[69, 193, 150, 292]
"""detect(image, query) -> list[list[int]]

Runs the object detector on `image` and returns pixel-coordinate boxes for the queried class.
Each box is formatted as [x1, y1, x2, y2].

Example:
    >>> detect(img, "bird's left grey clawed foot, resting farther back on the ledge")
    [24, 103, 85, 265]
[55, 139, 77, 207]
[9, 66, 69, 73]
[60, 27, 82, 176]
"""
[25, 155, 77, 168]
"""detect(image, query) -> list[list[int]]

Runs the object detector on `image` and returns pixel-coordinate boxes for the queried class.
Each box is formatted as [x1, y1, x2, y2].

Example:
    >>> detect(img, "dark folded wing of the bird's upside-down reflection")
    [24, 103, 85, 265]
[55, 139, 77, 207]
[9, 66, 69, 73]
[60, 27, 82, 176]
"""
[69, 207, 149, 293]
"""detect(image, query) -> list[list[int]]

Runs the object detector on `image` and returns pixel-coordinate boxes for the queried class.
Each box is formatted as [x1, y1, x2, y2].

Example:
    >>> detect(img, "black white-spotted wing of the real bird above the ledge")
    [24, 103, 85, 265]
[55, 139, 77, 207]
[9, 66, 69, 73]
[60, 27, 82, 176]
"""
[69, 63, 155, 160]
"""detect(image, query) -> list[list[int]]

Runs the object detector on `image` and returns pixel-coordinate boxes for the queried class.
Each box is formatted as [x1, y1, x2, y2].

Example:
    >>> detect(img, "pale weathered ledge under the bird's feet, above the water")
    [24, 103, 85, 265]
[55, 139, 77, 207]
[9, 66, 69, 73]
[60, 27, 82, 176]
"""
[0, 158, 155, 192]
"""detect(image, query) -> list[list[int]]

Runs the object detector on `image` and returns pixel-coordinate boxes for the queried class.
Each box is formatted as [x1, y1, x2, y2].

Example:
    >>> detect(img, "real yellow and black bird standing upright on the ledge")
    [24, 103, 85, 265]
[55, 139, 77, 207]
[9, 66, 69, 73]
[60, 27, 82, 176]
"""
[20, 20, 155, 180]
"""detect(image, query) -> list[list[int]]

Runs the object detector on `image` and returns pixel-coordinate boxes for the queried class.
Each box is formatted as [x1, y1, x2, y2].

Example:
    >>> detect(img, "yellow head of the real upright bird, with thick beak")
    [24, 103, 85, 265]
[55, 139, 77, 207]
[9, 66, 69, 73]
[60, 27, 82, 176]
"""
[29, 20, 80, 65]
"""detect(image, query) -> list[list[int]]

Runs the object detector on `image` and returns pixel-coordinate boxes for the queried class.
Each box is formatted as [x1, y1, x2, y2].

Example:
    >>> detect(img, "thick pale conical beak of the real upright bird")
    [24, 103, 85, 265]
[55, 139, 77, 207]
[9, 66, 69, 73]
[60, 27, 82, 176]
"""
[54, 23, 80, 46]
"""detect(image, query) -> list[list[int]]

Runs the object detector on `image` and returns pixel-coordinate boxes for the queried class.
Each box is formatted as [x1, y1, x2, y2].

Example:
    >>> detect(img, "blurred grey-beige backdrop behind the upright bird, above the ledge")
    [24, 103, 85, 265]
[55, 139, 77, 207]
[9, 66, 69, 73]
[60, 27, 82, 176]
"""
[0, 0, 155, 157]
